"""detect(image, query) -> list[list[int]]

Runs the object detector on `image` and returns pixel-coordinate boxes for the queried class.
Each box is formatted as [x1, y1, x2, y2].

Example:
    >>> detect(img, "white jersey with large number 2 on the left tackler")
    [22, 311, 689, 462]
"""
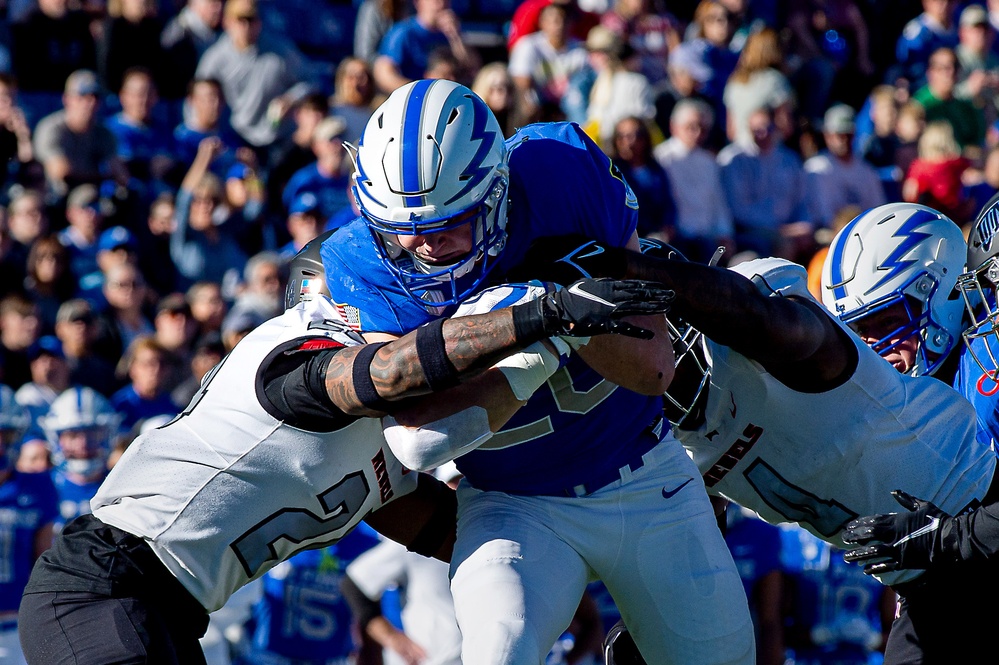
[92, 298, 416, 612]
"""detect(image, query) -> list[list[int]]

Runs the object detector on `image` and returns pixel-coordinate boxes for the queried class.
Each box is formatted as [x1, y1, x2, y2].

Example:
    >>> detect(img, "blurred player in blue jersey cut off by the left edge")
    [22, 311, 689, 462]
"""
[0, 384, 59, 664]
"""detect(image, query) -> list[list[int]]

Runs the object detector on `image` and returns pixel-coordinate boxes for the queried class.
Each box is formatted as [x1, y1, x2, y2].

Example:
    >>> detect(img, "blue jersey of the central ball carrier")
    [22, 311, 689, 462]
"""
[321, 123, 662, 494]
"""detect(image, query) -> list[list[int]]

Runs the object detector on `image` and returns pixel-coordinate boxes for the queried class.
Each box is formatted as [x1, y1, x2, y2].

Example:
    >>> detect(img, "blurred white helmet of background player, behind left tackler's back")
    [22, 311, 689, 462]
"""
[40, 386, 121, 477]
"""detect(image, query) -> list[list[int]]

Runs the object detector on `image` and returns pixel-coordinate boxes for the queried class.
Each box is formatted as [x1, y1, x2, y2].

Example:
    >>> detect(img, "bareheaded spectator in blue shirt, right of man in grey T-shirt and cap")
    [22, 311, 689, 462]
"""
[104, 67, 173, 195]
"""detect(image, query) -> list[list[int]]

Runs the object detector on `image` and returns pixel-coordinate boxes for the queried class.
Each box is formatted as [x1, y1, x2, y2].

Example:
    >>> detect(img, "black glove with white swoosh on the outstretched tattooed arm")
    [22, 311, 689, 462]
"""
[513, 279, 675, 339]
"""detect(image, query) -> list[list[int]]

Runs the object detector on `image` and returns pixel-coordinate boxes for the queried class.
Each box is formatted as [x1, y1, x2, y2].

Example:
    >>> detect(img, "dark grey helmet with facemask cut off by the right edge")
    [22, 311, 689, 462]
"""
[957, 194, 999, 380]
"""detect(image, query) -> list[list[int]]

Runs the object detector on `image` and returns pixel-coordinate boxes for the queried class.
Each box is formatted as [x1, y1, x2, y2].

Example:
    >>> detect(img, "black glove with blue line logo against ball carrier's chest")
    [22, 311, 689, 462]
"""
[505, 235, 626, 286]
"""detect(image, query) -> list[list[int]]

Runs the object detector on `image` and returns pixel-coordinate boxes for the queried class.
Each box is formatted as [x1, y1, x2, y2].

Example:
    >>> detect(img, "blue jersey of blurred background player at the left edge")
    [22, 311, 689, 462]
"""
[0, 471, 59, 613]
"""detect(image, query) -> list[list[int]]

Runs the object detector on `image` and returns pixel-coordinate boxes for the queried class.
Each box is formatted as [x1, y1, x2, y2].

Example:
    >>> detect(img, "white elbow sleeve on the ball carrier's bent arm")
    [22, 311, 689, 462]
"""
[382, 406, 493, 471]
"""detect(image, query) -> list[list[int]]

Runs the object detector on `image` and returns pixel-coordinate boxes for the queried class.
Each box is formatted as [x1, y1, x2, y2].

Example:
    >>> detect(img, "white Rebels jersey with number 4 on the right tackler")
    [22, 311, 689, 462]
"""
[676, 259, 996, 584]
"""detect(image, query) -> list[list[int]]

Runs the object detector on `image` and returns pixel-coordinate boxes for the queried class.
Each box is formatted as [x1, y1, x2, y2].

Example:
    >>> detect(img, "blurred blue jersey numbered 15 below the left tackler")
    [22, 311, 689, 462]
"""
[247, 522, 379, 665]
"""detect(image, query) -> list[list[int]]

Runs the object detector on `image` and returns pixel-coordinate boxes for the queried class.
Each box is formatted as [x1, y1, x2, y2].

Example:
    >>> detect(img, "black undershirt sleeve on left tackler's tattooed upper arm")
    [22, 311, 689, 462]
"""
[262, 348, 357, 432]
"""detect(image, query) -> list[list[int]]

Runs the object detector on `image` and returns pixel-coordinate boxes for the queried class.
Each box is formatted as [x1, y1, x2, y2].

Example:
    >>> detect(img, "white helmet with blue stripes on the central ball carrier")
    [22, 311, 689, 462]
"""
[352, 80, 509, 306]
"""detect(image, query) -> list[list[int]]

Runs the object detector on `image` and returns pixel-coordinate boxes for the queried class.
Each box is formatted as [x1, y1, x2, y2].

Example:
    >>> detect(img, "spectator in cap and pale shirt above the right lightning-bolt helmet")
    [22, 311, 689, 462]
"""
[804, 104, 886, 227]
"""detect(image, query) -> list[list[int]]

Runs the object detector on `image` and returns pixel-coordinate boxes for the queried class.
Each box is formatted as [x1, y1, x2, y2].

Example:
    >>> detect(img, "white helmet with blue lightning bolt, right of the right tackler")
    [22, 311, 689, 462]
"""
[822, 203, 967, 376]
